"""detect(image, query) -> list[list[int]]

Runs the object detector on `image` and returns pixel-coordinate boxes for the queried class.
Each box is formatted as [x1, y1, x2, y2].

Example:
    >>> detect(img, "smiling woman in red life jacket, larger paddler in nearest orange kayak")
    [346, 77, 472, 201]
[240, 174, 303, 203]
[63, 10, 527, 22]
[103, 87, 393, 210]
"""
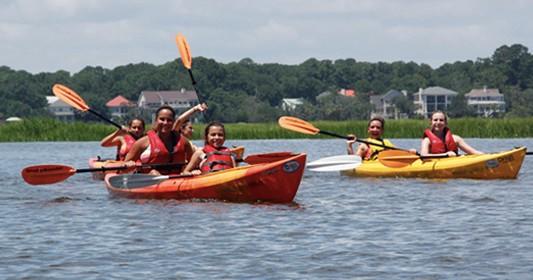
[125, 104, 207, 175]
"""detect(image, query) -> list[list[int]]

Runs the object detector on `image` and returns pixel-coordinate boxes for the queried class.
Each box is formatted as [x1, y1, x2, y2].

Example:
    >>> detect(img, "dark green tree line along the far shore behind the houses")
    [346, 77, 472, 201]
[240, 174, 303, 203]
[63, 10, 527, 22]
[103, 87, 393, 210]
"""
[0, 44, 533, 122]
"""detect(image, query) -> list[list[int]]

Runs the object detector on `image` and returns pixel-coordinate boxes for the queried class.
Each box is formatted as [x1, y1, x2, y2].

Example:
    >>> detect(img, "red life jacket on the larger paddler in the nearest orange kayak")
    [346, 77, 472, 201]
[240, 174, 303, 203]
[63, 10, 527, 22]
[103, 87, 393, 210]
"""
[145, 130, 190, 174]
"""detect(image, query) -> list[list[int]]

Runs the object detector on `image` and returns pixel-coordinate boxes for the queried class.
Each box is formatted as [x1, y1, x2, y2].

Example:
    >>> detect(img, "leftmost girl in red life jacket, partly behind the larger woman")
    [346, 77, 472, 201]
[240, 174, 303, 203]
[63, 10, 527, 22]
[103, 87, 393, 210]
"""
[100, 118, 144, 161]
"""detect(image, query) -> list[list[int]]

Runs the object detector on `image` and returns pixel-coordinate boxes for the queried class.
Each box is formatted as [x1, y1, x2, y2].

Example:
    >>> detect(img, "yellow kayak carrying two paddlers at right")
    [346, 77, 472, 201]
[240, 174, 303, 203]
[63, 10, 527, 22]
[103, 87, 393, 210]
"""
[341, 147, 526, 179]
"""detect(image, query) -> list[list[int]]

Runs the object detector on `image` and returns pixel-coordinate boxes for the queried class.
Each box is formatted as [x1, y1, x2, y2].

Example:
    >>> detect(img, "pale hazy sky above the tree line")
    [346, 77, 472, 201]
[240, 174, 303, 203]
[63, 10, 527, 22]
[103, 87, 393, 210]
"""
[0, 0, 533, 73]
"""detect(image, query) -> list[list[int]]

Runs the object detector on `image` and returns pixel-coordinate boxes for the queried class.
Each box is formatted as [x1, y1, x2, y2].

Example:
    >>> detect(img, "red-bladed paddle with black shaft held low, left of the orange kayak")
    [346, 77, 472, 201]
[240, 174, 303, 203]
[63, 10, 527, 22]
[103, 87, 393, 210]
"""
[21, 163, 184, 185]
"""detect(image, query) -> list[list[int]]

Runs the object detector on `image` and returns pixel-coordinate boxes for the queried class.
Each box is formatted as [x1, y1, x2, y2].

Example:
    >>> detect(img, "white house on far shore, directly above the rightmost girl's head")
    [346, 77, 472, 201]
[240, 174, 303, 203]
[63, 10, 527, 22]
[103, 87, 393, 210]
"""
[413, 87, 457, 118]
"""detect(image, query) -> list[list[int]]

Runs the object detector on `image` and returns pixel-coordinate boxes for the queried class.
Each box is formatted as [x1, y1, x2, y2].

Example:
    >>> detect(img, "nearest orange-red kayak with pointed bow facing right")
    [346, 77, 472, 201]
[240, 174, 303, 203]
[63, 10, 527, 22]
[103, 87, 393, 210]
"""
[105, 154, 306, 203]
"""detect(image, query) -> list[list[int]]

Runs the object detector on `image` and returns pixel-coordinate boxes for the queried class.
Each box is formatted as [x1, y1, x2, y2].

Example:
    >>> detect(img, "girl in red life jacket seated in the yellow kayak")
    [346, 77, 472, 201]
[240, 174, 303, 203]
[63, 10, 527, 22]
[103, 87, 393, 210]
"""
[420, 111, 483, 157]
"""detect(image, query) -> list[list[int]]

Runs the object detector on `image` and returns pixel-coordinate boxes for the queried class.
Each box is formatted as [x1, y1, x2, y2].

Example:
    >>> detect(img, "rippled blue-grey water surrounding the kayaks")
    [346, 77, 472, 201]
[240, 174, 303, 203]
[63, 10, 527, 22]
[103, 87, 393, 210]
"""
[0, 139, 533, 279]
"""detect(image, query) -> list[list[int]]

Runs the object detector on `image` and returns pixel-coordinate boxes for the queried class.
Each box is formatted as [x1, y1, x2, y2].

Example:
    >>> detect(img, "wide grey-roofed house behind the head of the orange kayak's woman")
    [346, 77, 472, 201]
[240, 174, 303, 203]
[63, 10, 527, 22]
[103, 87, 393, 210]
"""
[137, 88, 199, 121]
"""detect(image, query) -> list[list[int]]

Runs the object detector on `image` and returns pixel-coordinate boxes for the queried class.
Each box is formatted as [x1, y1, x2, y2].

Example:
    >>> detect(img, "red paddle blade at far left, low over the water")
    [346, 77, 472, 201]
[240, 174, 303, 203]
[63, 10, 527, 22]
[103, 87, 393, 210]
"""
[21, 164, 76, 185]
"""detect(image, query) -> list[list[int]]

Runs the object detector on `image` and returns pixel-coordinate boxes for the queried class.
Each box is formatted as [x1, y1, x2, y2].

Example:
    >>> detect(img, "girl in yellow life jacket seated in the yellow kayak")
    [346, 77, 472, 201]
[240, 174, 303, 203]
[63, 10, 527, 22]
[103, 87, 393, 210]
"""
[346, 116, 394, 160]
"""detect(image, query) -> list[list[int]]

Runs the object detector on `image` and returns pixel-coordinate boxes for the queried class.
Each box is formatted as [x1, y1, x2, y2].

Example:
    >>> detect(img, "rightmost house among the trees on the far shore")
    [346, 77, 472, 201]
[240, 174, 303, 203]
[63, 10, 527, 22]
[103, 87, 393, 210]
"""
[465, 86, 505, 117]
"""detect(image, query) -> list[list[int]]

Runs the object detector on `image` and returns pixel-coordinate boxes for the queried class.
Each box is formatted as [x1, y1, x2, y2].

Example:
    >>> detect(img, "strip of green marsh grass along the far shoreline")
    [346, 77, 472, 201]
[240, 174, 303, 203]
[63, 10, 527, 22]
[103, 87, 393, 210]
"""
[0, 118, 533, 142]
